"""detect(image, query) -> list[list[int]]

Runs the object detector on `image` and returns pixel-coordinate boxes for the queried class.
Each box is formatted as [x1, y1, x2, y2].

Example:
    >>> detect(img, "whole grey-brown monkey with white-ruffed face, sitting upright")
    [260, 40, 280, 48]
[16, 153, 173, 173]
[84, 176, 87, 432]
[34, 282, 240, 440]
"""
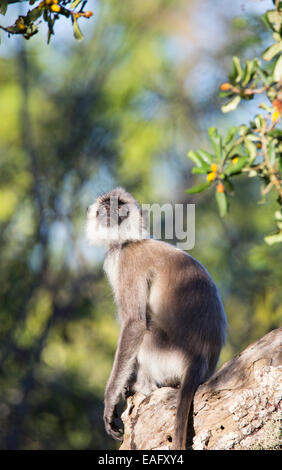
[86, 188, 227, 450]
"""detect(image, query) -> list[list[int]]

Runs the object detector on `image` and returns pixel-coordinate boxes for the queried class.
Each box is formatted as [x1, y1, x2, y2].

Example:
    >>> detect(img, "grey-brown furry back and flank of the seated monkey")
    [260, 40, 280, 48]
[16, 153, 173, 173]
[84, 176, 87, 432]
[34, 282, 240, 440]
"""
[120, 239, 226, 367]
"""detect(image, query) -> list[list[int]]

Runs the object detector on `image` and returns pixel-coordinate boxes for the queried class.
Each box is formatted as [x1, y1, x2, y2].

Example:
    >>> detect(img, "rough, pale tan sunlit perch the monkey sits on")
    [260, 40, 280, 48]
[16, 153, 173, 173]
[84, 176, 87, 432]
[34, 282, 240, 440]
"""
[120, 328, 282, 450]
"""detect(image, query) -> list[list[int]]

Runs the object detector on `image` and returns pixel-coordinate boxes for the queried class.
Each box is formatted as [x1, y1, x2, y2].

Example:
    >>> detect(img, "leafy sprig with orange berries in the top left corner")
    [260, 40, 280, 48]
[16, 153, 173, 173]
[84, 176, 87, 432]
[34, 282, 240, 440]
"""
[0, 0, 93, 43]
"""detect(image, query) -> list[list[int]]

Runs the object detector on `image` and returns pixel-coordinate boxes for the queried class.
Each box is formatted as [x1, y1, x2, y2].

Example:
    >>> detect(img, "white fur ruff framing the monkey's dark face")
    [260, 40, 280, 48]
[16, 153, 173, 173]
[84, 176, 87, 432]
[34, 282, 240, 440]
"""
[85, 202, 149, 247]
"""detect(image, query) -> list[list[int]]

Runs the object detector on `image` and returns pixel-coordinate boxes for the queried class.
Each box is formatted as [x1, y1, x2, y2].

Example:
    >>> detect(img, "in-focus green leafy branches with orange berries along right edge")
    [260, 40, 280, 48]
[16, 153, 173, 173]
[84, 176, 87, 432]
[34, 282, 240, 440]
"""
[186, 1, 282, 244]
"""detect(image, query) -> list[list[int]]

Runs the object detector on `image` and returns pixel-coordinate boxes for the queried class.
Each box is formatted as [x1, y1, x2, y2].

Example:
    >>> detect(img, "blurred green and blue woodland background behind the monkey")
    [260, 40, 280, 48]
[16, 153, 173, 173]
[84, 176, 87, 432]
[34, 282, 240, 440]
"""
[0, 0, 282, 449]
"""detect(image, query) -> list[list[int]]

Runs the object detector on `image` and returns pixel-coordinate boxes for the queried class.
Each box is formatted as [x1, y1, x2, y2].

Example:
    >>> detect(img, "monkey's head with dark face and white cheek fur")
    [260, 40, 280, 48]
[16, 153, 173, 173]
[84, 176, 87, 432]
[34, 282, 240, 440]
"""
[86, 188, 148, 247]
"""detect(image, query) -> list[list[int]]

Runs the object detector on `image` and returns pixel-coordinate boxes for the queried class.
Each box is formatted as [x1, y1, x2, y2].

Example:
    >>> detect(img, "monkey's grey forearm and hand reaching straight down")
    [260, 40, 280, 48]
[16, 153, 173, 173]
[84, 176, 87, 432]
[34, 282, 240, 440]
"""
[104, 319, 146, 440]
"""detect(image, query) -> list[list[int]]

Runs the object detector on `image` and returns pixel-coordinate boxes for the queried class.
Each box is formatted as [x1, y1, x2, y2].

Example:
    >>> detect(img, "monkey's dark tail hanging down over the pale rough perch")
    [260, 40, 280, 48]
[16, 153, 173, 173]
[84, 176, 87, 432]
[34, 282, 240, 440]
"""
[172, 357, 207, 450]
